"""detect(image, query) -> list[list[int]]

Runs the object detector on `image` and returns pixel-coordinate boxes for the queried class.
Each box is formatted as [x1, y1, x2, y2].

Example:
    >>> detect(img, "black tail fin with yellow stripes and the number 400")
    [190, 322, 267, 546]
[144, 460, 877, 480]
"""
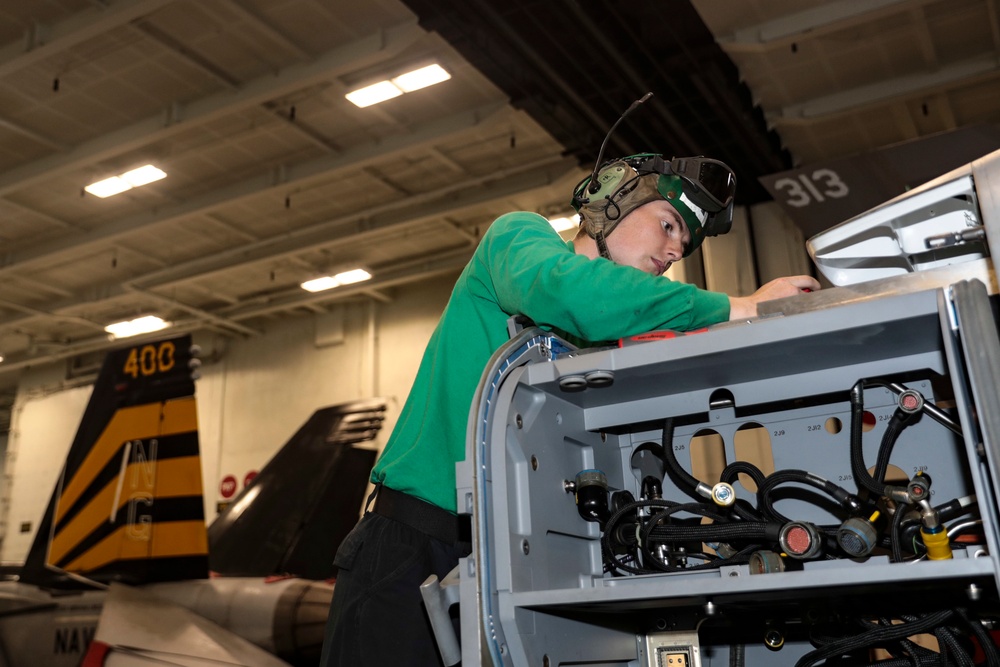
[21, 336, 208, 586]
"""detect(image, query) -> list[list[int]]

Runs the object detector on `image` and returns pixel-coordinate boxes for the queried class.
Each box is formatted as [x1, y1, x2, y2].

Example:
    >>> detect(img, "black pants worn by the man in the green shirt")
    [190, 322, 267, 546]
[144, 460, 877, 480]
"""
[320, 513, 465, 667]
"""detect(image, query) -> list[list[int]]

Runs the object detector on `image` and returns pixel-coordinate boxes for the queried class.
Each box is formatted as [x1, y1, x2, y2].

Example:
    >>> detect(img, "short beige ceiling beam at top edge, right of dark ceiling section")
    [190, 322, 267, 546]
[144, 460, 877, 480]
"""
[717, 0, 932, 53]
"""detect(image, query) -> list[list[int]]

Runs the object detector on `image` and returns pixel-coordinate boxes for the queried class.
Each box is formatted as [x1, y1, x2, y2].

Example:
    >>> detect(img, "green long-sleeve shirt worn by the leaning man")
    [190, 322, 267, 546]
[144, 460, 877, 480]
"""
[372, 212, 729, 512]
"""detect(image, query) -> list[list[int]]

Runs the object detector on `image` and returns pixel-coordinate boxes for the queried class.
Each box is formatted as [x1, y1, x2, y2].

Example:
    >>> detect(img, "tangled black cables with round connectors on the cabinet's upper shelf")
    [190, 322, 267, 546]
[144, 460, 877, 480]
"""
[601, 380, 976, 576]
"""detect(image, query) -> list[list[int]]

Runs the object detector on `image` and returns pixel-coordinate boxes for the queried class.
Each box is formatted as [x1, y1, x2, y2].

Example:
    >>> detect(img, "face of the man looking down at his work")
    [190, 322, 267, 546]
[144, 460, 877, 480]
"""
[607, 199, 691, 276]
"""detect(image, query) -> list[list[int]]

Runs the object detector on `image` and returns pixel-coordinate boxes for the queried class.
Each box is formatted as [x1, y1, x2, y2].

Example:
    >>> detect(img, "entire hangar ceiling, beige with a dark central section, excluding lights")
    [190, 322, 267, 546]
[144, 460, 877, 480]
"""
[0, 0, 1000, 412]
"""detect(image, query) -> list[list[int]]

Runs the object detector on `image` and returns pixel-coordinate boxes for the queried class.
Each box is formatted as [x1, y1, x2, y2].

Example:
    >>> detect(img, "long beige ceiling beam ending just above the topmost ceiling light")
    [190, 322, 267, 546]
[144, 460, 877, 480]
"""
[0, 22, 424, 196]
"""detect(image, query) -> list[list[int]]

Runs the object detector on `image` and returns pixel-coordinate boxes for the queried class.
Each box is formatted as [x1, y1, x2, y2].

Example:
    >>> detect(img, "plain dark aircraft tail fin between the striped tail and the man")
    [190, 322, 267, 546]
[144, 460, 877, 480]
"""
[208, 399, 386, 579]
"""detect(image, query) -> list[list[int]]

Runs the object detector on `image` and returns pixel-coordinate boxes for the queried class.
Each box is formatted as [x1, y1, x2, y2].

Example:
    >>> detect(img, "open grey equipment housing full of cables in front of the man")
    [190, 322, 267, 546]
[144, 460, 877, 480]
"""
[424, 149, 1000, 667]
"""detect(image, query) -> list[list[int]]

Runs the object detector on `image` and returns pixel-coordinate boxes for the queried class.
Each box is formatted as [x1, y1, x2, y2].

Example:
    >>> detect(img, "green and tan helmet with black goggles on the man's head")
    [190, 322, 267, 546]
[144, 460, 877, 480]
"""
[572, 153, 736, 257]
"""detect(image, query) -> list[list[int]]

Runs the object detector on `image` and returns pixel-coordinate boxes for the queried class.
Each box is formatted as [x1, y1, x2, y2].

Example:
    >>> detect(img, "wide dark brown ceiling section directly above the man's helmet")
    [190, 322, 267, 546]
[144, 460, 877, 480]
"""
[403, 0, 791, 202]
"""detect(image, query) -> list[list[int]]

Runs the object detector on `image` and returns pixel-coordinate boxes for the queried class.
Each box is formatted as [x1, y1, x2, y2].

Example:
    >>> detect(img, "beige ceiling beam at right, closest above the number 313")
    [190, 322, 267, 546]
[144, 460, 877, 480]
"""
[767, 53, 1000, 125]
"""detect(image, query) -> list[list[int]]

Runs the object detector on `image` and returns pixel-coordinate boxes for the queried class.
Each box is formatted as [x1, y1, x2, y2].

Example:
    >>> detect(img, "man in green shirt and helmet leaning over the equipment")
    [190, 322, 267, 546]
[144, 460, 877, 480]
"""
[321, 154, 820, 666]
